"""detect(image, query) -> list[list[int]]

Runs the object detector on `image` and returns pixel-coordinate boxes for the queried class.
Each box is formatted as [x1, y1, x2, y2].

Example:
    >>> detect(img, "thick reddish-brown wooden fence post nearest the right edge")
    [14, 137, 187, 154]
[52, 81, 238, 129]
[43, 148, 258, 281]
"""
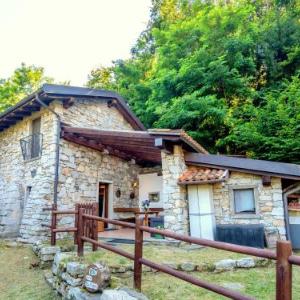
[276, 241, 292, 300]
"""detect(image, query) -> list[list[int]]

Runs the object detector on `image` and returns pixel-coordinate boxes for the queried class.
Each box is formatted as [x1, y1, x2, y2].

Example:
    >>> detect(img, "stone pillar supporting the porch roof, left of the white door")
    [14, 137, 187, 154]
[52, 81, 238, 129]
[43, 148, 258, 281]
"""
[162, 145, 188, 234]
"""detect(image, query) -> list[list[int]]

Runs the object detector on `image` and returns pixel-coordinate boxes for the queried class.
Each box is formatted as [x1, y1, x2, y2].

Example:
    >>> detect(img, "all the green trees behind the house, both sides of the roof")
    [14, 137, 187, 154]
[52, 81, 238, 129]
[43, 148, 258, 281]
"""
[0, 0, 300, 163]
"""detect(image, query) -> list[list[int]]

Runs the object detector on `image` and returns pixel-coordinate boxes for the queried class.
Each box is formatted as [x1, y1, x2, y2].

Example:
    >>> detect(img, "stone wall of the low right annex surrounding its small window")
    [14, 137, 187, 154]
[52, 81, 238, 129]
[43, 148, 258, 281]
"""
[213, 172, 286, 239]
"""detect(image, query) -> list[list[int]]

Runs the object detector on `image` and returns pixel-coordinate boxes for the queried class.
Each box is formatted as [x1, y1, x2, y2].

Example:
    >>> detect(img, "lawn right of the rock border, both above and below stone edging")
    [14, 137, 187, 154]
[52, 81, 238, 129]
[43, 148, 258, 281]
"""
[71, 245, 300, 300]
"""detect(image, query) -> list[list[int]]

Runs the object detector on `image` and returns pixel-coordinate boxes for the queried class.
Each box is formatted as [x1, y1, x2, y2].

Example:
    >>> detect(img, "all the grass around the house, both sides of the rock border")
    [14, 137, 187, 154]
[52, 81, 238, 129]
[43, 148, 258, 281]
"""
[0, 243, 300, 300]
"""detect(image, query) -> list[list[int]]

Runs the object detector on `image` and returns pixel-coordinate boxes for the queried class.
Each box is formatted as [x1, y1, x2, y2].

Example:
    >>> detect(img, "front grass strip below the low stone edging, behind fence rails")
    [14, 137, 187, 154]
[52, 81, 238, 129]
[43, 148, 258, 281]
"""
[119, 267, 300, 300]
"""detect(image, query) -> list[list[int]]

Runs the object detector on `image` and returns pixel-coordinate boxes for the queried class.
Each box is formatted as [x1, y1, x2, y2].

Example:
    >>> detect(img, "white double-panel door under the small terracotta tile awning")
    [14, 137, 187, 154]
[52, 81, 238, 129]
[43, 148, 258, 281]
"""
[188, 185, 215, 240]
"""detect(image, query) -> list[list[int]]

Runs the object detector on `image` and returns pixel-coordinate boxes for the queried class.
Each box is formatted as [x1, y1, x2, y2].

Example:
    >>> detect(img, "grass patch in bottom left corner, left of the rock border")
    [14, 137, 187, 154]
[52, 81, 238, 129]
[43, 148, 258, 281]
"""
[0, 242, 58, 300]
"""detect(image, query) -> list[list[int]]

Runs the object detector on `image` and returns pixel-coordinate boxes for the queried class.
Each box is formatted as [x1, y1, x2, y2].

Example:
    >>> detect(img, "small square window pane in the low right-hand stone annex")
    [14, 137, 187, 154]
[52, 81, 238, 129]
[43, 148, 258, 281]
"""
[233, 188, 256, 214]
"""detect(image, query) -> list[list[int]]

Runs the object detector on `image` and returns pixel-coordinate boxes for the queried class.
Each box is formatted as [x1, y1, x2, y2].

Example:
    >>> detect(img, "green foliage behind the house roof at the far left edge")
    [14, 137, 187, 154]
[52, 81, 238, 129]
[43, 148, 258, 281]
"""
[0, 64, 53, 112]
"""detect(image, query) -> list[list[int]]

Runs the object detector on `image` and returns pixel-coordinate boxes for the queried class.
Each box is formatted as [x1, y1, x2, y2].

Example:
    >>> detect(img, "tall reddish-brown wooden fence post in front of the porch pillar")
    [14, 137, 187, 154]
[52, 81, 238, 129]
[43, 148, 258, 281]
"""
[134, 214, 143, 291]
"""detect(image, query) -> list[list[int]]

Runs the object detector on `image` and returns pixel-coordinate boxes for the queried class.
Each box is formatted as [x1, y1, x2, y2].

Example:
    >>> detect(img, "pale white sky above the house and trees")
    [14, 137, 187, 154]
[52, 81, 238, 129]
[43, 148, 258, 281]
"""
[0, 0, 151, 85]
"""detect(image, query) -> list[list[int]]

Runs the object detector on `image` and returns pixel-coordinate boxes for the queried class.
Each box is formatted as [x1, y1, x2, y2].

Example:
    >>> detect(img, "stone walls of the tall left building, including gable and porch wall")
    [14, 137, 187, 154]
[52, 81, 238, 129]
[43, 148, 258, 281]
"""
[0, 99, 145, 242]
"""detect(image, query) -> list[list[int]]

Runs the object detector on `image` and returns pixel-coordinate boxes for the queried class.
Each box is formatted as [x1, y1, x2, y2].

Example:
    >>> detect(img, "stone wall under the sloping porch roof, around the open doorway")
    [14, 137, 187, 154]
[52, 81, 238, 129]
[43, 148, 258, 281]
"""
[58, 141, 141, 217]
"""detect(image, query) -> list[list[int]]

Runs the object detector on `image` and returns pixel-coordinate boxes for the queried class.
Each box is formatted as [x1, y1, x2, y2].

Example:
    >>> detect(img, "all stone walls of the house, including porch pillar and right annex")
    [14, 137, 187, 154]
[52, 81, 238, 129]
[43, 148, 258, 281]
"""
[0, 99, 285, 242]
